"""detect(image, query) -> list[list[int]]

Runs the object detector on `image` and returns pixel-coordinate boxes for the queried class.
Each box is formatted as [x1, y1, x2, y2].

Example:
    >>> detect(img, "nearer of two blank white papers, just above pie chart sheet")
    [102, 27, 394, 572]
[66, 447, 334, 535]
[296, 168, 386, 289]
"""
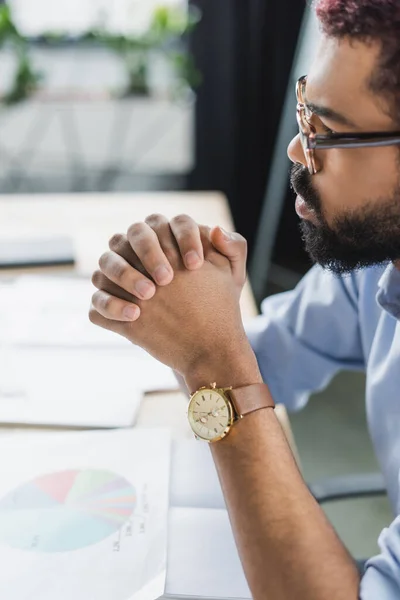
[0, 348, 143, 427]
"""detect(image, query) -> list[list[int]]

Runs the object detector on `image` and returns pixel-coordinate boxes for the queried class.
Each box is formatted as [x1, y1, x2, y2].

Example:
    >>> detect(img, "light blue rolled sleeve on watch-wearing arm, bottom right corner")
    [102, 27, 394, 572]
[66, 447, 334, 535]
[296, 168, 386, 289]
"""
[359, 516, 400, 600]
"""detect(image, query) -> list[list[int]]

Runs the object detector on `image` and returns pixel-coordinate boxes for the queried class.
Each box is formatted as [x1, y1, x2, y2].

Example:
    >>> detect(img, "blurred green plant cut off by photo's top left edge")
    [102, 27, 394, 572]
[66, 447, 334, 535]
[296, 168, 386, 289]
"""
[0, 4, 40, 105]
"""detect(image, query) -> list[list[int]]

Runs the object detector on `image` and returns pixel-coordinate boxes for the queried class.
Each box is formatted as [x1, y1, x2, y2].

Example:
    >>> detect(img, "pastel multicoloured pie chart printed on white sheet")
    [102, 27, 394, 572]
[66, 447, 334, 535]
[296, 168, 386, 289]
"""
[0, 469, 136, 553]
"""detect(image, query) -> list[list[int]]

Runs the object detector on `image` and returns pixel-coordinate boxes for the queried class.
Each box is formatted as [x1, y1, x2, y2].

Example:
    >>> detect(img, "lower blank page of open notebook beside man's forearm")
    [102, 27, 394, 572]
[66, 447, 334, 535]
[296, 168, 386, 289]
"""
[164, 508, 251, 600]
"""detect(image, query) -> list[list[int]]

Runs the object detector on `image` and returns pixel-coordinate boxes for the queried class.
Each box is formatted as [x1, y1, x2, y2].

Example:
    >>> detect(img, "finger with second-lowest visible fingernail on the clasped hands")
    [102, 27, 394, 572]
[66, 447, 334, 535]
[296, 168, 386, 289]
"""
[99, 251, 156, 300]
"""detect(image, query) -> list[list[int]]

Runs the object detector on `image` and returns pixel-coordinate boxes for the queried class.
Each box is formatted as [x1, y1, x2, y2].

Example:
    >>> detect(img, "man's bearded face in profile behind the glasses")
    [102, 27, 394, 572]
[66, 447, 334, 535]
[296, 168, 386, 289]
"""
[288, 37, 400, 273]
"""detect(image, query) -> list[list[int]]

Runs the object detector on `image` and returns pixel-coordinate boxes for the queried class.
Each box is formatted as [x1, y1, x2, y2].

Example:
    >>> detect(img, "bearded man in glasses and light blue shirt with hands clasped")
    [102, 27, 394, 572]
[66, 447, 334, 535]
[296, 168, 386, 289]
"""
[90, 0, 400, 600]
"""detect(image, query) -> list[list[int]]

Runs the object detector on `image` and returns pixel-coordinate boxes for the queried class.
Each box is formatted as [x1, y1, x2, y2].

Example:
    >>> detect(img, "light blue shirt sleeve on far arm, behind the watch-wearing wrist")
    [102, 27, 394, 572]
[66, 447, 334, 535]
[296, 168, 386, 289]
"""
[246, 265, 365, 410]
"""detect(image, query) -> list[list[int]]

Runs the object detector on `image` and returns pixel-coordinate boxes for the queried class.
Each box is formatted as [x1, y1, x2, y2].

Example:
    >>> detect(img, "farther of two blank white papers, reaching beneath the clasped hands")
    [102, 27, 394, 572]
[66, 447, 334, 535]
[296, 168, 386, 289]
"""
[0, 276, 178, 392]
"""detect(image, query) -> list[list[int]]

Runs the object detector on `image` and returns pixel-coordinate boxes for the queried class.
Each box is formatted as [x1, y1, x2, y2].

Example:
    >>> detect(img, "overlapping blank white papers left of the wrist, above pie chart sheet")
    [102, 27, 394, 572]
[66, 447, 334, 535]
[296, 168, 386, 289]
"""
[0, 276, 178, 427]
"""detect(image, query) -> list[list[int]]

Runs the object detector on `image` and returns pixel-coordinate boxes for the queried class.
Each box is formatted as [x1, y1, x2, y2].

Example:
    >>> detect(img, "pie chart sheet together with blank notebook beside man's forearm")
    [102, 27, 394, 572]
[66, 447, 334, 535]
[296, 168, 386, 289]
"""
[0, 429, 251, 600]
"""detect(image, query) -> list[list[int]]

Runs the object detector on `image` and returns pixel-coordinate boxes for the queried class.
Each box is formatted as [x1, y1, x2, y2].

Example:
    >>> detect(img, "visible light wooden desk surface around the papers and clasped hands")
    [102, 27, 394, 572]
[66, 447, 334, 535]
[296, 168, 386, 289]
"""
[0, 193, 297, 457]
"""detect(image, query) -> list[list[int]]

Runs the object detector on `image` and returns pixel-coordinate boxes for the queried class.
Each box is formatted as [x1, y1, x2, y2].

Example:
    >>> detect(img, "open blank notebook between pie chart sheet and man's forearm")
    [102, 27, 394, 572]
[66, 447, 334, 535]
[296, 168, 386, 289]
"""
[163, 440, 251, 600]
